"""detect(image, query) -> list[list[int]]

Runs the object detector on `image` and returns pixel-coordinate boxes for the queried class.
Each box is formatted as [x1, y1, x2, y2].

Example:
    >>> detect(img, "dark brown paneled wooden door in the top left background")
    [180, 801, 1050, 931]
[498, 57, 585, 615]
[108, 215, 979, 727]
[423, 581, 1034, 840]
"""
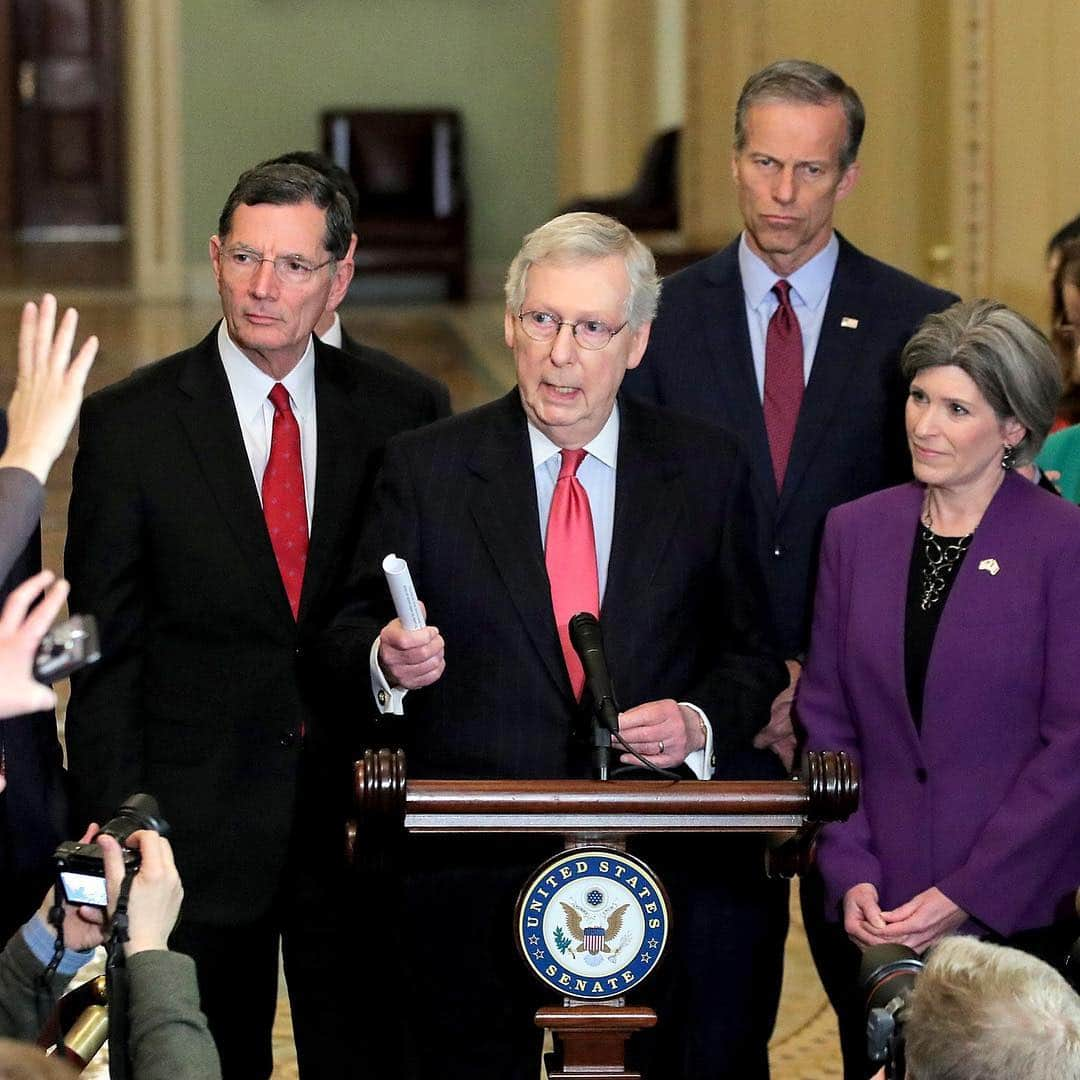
[11, 0, 124, 240]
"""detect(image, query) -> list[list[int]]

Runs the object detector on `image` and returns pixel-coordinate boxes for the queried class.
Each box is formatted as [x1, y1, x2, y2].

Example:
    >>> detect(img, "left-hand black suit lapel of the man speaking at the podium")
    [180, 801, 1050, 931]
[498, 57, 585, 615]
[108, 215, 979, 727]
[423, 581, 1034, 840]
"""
[468, 389, 570, 694]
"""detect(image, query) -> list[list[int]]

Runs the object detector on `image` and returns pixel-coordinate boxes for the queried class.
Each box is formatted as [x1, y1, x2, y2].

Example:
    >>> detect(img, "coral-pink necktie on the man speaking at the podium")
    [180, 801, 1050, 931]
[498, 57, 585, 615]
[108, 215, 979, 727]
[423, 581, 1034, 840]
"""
[544, 450, 600, 698]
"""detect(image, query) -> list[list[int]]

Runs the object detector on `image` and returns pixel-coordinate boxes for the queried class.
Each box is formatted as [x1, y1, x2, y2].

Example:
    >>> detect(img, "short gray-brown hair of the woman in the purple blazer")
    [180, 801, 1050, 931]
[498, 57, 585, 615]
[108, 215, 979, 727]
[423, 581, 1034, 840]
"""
[900, 300, 1062, 465]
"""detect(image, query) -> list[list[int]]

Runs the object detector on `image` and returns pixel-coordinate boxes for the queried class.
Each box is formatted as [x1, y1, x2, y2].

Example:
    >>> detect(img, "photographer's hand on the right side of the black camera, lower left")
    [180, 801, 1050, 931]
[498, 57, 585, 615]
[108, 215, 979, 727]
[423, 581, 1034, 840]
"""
[97, 828, 184, 956]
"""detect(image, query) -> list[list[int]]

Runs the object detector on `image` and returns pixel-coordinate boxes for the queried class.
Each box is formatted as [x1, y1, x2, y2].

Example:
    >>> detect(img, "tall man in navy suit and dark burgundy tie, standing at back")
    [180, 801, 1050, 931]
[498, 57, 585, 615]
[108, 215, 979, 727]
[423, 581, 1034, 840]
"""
[626, 60, 956, 1080]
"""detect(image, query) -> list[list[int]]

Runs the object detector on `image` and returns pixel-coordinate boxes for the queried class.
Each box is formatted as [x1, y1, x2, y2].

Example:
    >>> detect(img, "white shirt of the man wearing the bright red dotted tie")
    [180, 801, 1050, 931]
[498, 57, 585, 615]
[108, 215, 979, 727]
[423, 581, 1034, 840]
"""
[217, 319, 319, 534]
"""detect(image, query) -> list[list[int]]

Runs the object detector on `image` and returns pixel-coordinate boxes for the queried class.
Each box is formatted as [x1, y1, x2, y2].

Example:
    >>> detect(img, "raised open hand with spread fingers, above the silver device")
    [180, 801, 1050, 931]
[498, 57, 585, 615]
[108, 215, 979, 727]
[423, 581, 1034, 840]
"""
[0, 293, 97, 484]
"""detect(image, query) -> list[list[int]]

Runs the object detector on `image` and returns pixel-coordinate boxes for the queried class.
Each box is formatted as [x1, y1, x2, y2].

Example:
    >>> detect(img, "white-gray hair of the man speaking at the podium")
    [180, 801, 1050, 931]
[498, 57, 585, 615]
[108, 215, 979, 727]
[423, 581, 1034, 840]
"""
[505, 213, 660, 332]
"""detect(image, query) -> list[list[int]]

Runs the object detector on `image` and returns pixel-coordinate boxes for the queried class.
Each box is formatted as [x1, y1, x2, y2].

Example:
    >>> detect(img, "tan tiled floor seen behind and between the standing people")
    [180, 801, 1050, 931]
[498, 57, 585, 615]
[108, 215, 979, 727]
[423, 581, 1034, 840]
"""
[0, 283, 840, 1080]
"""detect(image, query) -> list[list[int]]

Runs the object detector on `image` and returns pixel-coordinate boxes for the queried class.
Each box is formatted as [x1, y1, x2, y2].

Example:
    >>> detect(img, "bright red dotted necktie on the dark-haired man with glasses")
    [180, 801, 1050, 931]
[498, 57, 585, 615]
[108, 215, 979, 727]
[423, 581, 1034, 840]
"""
[262, 382, 308, 619]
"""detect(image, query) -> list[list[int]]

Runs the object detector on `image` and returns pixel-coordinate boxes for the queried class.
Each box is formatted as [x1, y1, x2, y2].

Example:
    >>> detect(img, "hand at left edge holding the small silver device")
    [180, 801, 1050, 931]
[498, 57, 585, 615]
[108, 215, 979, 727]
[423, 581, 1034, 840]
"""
[0, 570, 68, 730]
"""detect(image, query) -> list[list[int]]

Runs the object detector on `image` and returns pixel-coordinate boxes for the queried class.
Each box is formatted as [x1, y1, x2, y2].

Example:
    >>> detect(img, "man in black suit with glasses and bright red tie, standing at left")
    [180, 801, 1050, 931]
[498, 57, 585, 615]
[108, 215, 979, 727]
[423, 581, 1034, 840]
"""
[67, 165, 451, 1078]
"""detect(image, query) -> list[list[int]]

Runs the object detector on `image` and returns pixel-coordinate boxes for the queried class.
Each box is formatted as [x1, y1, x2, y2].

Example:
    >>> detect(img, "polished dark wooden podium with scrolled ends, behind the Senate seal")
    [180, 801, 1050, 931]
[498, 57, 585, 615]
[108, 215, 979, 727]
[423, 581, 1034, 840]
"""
[347, 750, 859, 1080]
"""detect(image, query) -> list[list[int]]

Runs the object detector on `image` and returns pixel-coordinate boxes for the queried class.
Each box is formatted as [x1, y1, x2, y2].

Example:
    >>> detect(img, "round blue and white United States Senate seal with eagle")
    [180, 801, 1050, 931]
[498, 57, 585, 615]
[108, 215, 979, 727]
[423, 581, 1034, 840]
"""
[517, 848, 669, 1001]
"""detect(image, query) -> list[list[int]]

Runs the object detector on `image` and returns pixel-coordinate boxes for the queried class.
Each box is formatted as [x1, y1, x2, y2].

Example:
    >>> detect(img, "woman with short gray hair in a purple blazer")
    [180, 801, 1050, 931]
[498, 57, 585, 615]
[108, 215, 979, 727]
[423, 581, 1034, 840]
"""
[797, 300, 1080, 1076]
